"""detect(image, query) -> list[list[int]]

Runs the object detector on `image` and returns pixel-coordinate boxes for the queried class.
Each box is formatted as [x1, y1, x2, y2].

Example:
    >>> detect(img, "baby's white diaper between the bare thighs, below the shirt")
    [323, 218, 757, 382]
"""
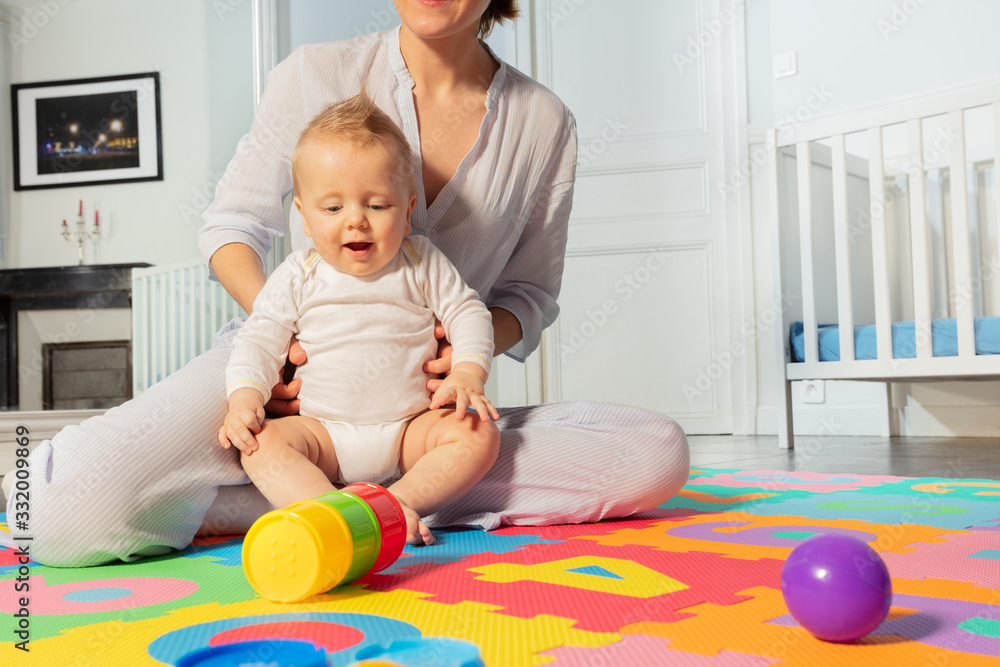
[319, 418, 410, 486]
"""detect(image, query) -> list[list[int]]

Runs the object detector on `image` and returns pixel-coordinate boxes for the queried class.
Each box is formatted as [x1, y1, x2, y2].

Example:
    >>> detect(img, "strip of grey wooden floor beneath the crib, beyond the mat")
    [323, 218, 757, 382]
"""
[688, 435, 1000, 480]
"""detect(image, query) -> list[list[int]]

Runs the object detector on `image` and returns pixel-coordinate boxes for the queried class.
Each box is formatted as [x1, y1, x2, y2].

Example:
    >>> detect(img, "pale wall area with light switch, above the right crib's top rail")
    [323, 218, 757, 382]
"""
[746, 0, 1000, 125]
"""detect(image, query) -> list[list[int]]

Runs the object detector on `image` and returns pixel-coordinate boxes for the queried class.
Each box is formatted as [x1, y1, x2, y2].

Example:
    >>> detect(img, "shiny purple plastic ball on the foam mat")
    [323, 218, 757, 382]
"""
[781, 533, 892, 642]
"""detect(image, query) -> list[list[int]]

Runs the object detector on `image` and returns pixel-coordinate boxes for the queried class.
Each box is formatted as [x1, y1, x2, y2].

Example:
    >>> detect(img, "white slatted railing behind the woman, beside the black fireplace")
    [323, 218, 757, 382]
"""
[132, 259, 245, 396]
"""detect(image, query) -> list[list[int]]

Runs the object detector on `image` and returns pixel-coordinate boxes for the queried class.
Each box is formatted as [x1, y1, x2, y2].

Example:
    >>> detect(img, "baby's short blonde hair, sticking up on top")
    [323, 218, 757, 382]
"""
[292, 90, 417, 195]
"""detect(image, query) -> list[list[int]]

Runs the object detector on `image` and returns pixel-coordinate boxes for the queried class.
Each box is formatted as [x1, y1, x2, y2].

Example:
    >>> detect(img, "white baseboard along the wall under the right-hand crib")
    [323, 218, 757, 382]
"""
[757, 405, 1000, 438]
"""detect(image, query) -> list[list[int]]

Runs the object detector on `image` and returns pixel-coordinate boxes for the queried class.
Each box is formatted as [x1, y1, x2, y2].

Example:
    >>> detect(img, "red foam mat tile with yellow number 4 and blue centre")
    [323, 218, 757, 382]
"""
[368, 540, 782, 632]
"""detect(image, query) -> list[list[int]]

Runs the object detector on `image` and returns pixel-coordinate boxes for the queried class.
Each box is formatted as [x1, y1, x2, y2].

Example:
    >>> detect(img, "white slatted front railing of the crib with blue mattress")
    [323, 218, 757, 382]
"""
[767, 82, 1000, 447]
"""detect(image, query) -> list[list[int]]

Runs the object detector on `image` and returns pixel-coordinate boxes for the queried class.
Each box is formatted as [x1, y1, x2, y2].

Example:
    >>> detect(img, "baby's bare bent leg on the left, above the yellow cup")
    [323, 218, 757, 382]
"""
[240, 415, 339, 508]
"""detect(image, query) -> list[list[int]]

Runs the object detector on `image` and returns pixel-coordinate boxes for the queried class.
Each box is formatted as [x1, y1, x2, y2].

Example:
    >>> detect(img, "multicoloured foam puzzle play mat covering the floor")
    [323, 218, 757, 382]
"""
[0, 468, 1000, 667]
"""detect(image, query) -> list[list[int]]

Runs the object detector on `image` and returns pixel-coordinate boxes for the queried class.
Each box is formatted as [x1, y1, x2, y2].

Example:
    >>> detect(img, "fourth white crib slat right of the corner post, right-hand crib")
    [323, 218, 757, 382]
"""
[907, 118, 933, 359]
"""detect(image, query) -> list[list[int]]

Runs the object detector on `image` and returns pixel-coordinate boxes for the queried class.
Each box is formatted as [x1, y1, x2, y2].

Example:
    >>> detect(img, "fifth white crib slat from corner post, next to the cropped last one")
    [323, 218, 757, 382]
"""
[948, 109, 976, 357]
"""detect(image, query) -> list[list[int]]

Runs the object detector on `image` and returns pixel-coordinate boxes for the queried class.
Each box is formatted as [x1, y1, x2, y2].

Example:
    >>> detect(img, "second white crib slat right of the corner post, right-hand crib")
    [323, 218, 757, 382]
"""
[830, 134, 854, 361]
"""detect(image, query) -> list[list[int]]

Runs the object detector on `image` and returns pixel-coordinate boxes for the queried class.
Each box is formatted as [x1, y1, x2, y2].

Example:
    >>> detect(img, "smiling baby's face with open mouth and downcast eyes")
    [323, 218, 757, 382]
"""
[295, 139, 417, 276]
